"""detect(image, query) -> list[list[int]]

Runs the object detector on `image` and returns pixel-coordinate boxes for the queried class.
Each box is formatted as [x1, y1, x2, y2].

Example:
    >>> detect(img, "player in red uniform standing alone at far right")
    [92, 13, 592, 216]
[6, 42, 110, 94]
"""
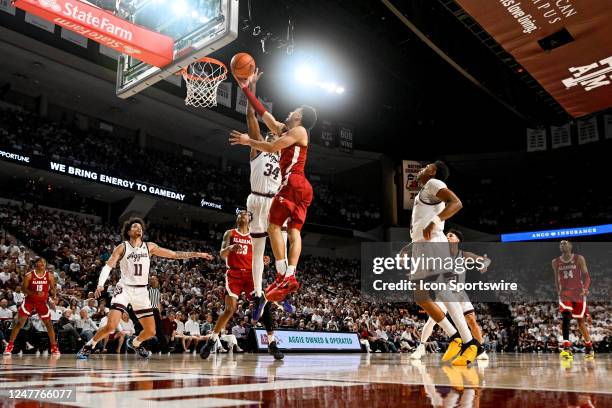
[552, 240, 595, 360]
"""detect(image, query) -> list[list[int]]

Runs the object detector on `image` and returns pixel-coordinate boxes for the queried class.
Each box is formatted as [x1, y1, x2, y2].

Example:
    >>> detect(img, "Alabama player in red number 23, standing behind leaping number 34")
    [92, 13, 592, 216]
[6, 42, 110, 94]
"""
[200, 211, 284, 360]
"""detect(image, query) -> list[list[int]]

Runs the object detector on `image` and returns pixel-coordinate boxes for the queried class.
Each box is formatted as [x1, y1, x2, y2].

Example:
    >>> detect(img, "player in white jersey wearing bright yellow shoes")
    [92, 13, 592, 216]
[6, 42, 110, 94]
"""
[410, 161, 480, 365]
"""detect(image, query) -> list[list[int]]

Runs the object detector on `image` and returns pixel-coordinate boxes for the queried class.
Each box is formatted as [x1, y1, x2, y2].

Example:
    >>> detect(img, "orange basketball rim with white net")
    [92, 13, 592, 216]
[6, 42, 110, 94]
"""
[180, 57, 227, 108]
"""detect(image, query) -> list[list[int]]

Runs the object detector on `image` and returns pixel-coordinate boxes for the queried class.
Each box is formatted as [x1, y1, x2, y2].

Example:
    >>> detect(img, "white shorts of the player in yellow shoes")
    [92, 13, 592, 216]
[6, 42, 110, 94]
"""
[410, 231, 451, 280]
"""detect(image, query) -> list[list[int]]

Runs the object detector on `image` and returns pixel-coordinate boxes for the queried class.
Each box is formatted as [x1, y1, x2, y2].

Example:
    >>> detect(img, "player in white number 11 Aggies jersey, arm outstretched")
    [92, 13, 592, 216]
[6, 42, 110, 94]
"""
[77, 218, 213, 359]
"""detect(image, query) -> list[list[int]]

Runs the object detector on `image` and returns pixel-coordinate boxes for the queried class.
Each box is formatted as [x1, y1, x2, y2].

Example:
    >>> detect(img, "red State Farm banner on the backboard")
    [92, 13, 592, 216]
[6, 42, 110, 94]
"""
[14, 0, 174, 68]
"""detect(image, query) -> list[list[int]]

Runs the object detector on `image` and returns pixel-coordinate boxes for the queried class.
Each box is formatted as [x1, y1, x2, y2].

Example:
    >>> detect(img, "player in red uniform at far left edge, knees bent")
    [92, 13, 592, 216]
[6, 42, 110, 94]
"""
[4, 258, 60, 356]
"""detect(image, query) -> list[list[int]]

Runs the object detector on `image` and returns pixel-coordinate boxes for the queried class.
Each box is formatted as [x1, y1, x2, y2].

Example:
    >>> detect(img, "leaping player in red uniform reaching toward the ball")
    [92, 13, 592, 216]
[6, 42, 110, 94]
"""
[230, 75, 317, 301]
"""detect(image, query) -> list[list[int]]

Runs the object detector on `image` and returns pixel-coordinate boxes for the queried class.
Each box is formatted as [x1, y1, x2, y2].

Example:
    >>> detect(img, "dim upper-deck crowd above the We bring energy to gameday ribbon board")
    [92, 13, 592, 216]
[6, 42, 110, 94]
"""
[0, 109, 381, 230]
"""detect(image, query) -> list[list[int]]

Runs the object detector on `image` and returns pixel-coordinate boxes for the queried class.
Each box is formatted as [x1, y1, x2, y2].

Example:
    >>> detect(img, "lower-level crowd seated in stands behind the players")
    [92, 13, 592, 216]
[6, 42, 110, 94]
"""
[0, 205, 612, 352]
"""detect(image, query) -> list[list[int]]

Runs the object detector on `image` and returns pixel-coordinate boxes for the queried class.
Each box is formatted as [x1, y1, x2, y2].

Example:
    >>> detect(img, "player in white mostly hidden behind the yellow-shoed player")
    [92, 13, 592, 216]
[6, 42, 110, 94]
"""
[410, 229, 491, 360]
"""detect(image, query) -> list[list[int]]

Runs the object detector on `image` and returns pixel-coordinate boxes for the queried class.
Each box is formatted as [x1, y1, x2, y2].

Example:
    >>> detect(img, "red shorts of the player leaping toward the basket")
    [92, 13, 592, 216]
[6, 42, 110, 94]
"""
[270, 174, 312, 231]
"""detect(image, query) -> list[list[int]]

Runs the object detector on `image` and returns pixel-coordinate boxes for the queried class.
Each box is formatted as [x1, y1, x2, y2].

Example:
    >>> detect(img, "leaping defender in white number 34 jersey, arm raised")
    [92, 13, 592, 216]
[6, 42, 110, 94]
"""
[247, 70, 292, 322]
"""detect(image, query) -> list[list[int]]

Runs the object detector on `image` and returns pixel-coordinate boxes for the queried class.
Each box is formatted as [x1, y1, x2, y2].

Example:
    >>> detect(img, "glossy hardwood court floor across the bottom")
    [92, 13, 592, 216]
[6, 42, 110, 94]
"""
[0, 353, 612, 408]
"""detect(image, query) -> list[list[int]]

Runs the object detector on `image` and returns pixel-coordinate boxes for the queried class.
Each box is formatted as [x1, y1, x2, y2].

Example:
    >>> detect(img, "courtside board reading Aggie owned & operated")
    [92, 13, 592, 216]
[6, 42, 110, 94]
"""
[254, 329, 361, 353]
